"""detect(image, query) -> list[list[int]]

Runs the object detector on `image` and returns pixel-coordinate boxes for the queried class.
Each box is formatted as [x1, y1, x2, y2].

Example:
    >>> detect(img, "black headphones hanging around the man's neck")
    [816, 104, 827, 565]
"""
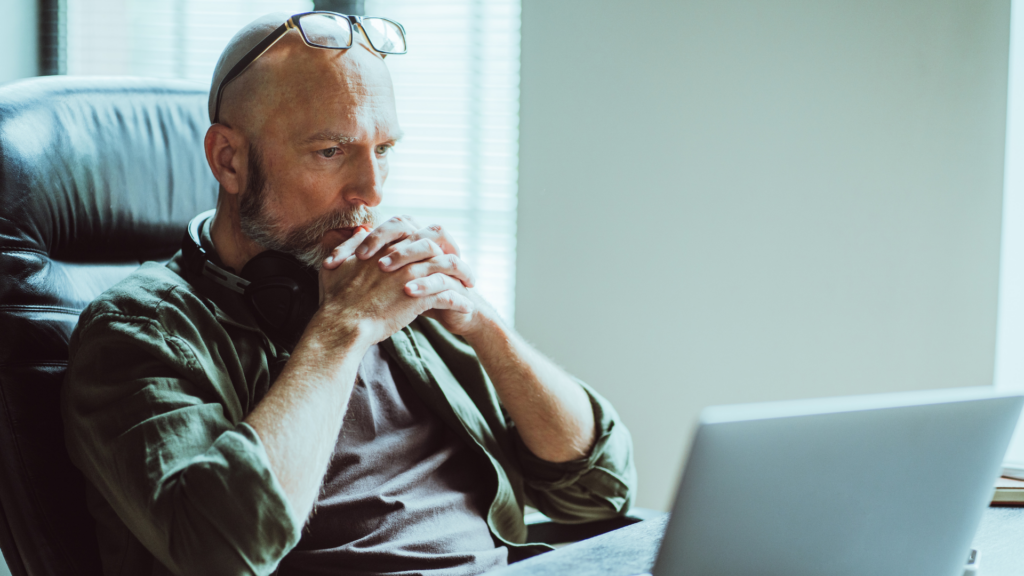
[181, 210, 319, 349]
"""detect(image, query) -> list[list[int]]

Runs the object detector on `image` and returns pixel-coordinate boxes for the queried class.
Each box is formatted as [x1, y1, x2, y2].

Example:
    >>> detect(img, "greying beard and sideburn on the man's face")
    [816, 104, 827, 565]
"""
[239, 146, 380, 271]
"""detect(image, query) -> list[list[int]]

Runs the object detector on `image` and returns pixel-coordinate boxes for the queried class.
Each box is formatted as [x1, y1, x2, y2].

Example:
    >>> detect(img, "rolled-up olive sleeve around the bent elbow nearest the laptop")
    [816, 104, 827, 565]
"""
[512, 382, 637, 523]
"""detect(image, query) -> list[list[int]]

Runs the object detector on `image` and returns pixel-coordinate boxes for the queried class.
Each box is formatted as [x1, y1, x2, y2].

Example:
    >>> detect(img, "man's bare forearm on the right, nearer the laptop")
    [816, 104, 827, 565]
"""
[464, 307, 596, 462]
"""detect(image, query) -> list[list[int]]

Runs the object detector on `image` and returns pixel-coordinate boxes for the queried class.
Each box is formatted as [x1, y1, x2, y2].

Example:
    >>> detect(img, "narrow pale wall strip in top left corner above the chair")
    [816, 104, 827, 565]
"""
[0, 0, 39, 84]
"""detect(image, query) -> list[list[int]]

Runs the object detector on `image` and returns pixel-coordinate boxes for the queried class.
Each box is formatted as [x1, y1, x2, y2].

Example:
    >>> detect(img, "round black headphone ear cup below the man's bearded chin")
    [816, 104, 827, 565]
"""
[242, 250, 319, 349]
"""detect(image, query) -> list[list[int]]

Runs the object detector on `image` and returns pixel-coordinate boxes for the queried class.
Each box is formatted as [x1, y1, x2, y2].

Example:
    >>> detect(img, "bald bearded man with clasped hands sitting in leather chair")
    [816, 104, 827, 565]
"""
[62, 10, 636, 575]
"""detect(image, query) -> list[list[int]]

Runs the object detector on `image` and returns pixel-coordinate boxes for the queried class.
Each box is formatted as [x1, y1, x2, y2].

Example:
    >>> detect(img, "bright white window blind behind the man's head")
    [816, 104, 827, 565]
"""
[65, 0, 520, 322]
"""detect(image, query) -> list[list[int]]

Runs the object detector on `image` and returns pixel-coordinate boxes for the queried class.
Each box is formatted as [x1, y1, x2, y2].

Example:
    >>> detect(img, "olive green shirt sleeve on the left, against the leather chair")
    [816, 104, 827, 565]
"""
[61, 314, 301, 574]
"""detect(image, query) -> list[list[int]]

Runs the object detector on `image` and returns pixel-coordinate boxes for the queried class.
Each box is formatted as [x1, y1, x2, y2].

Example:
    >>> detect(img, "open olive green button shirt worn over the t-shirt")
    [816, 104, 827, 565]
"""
[61, 253, 636, 576]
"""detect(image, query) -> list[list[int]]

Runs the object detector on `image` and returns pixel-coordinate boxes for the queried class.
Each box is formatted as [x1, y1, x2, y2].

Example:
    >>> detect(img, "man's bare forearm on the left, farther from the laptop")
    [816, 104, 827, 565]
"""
[245, 319, 367, 525]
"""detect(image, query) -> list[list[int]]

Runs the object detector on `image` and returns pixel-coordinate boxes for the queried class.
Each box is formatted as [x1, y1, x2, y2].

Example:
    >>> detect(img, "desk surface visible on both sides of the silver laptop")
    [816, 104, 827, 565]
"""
[488, 508, 1024, 576]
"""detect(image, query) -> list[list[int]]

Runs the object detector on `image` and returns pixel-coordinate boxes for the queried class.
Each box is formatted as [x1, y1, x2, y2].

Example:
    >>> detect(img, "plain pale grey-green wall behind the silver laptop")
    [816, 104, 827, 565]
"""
[516, 0, 1010, 508]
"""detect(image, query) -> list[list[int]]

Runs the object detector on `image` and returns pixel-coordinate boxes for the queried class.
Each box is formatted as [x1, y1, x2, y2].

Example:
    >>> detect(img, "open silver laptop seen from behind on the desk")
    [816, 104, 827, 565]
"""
[652, 387, 1024, 576]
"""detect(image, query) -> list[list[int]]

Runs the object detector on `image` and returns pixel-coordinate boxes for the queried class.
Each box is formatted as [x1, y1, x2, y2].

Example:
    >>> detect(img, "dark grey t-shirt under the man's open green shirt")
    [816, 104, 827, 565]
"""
[279, 345, 508, 576]
